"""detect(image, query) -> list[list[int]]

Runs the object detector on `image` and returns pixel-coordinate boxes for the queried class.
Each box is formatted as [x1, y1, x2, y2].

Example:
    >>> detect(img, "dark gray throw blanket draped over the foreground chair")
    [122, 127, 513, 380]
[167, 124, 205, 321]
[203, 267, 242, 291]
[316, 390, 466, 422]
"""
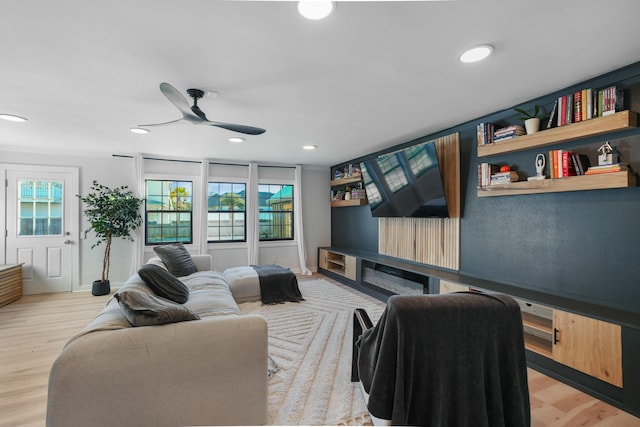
[358, 292, 531, 427]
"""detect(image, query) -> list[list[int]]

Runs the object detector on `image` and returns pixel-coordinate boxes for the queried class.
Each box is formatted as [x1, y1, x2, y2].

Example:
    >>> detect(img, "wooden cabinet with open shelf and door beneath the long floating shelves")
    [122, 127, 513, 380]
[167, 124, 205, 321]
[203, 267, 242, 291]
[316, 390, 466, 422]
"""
[518, 301, 622, 387]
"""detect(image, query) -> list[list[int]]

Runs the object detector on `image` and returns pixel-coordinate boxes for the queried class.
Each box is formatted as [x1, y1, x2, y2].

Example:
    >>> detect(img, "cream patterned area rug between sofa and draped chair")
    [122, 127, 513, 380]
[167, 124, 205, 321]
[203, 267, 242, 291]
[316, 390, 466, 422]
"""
[240, 279, 384, 425]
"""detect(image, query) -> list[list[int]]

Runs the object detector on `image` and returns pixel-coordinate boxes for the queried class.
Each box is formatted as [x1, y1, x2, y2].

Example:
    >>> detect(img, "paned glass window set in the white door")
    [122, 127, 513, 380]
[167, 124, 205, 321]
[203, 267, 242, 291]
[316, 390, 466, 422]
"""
[16, 180, 63, 236]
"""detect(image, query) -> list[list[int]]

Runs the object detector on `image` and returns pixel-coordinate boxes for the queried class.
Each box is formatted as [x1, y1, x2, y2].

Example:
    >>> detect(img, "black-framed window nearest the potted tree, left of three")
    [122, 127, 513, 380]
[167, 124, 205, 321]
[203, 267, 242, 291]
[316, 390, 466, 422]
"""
[145, 179, 193, 245]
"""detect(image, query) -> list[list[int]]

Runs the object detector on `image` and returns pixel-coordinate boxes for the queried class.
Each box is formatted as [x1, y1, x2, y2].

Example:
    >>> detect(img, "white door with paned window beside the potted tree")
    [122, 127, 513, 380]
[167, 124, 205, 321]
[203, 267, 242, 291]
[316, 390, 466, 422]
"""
[5, 165, 79, 295]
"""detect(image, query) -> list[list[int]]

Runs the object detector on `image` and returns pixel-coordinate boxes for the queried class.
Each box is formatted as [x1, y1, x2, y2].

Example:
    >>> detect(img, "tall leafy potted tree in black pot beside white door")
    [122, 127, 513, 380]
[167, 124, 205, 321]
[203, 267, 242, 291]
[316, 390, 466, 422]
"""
[76, 180, 143, 295]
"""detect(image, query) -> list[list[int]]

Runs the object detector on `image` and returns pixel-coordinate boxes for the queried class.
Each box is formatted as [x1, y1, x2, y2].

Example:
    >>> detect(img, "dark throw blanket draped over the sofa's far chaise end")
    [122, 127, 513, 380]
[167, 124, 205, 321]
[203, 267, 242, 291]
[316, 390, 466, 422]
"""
[251, 264, 304, 304]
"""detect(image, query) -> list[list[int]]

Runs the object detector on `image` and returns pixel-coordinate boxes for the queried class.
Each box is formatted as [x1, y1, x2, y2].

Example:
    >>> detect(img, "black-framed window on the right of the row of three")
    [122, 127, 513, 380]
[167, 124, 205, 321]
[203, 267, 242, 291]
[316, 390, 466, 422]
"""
[258, 184, 293, 241]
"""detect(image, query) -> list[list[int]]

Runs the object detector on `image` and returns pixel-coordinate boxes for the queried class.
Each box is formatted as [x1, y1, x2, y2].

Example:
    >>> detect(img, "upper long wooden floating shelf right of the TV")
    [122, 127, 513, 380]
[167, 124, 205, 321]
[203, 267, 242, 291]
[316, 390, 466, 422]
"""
[478, 110, 638, 157]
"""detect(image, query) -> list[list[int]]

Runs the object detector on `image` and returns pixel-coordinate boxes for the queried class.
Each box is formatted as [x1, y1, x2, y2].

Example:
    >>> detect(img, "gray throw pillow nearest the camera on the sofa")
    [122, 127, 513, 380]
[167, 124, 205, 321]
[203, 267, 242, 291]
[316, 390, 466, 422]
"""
[114, 290, 200, 326]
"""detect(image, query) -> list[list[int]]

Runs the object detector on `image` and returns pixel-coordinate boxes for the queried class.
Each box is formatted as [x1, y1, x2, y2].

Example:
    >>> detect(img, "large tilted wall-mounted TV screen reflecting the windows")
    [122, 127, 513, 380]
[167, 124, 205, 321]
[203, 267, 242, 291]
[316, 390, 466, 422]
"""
[360, 141, 449, 218]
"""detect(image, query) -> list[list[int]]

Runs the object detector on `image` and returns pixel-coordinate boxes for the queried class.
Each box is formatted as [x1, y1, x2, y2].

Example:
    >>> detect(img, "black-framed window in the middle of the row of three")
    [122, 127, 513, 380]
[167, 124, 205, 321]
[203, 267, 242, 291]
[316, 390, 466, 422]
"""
[207, 182, 247, 242]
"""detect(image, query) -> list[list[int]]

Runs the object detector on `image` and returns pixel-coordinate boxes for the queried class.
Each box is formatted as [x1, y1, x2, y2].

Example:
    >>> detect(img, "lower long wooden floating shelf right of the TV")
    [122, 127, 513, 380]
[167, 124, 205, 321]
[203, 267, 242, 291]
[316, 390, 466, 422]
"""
[478, 171, 636, 197]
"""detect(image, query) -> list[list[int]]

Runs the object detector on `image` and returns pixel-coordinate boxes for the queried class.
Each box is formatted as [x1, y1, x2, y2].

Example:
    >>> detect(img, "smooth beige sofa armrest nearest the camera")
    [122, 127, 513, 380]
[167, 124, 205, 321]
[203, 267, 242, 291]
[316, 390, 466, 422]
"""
[47, 315, 268, 427]
